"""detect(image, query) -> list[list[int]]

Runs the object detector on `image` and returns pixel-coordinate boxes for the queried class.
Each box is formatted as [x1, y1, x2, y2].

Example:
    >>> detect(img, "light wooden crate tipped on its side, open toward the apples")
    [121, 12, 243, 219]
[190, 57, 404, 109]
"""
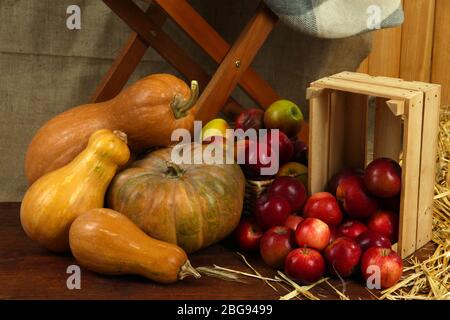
[307, 72, 441, 257]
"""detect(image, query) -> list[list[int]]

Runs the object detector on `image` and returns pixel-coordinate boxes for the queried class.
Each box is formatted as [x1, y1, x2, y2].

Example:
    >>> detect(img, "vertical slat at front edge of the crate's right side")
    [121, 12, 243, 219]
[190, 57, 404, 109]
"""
[398, 92, 424, 257]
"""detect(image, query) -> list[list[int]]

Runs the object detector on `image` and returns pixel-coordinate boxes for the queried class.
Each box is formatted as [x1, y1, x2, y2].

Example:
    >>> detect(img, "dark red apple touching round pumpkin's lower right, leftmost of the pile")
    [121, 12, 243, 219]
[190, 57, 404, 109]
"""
[234, 218, 264, 251]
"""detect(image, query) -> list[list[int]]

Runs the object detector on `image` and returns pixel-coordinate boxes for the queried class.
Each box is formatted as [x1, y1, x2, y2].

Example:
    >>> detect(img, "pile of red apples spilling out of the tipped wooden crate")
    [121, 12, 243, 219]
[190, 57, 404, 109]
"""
[235, 158, 403, 288]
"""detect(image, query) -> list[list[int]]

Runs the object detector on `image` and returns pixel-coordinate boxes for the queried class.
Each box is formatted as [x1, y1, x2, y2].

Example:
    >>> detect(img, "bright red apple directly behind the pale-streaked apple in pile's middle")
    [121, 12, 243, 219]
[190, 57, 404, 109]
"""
[303, 192, 342, 226]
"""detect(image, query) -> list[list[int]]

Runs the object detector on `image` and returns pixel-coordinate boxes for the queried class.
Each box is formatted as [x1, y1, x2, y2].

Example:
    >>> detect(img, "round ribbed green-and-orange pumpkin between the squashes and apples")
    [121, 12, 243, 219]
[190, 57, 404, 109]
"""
[107, 144, 245, 252]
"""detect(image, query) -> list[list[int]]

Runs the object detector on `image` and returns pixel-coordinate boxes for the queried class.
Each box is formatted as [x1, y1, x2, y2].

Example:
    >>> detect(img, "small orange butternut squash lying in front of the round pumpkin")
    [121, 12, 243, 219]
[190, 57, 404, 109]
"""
[70, 209, 200, 283]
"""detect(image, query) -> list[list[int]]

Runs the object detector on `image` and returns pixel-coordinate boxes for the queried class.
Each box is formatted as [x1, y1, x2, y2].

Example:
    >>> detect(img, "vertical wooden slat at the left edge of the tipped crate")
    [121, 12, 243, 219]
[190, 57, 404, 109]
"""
[308, 88, 330, 194]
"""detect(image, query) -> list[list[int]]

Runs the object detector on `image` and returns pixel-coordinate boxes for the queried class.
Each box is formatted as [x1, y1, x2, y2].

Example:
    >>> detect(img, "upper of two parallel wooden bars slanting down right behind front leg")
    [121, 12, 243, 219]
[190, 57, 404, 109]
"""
[156, 0, 279, 108]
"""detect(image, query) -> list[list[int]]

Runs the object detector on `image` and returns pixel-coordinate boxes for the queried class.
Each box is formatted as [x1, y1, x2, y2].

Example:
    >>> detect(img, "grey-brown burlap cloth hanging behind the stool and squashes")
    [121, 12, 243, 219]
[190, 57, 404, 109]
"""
[0, 0, 370, 201]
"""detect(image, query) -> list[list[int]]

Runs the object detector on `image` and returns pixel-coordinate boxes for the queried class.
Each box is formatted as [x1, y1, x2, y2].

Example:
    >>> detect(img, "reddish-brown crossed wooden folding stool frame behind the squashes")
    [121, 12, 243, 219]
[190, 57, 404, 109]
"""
[91, 0, 279, 121]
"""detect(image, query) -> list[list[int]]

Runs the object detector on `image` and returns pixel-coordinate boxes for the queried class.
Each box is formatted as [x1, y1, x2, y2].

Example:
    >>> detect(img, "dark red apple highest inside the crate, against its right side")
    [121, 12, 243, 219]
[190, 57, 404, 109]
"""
[364, 158, 402, 198]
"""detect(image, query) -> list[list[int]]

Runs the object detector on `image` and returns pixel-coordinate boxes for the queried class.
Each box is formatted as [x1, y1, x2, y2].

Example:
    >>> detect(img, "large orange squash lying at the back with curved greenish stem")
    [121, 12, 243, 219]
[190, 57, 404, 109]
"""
[25, 74, 198, 184]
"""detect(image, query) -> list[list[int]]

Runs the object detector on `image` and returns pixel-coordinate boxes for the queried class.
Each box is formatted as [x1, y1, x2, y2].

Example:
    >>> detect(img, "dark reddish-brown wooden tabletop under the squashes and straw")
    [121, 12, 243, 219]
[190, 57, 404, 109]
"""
[0, 203, 434, 300]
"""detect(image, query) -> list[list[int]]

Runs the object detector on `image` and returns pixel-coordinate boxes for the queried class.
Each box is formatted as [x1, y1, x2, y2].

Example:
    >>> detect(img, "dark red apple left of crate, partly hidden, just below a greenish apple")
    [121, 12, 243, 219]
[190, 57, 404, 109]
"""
[268, 176, 307, 211]
